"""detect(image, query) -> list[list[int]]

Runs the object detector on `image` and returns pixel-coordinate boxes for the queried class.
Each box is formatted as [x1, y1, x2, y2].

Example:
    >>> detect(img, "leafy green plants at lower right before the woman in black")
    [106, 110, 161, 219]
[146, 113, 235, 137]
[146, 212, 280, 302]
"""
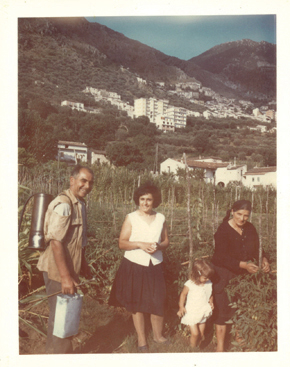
[227, 271, 277, 351]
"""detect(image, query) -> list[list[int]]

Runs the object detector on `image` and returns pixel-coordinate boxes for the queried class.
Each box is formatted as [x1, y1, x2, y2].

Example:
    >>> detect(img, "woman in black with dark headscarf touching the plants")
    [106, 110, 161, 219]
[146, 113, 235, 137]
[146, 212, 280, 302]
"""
[212, 200, 270, 352]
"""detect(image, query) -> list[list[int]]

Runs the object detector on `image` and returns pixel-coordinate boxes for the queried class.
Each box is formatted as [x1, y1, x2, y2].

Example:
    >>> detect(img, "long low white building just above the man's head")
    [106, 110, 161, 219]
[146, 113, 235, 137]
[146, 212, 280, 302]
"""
[57, 141, 88, 164]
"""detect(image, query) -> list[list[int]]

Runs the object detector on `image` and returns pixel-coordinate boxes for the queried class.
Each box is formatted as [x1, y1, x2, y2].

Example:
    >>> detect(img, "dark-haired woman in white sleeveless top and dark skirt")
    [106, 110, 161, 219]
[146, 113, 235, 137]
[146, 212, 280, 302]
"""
[109, 183, 169, 352]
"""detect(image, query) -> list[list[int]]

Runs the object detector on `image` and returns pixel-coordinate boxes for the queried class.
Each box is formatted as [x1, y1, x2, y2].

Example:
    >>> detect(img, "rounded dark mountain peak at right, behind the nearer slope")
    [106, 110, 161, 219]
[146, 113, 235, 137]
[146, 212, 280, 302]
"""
[189, 39, 276, 98]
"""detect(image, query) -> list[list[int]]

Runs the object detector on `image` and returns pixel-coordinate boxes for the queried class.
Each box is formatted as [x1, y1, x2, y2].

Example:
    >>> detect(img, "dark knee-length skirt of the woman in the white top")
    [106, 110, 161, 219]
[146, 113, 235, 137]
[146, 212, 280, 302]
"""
[109, 258, 166, 316]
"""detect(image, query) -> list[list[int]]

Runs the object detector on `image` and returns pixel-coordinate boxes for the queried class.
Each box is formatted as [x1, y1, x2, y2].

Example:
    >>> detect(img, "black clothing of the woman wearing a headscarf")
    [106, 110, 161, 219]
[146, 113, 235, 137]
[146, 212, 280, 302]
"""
[212, 221, 264, 325]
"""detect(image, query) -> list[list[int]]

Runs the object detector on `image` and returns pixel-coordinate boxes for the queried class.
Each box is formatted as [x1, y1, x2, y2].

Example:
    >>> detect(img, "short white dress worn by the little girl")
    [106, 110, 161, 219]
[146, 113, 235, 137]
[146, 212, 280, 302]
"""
[181, 280, 212, 325]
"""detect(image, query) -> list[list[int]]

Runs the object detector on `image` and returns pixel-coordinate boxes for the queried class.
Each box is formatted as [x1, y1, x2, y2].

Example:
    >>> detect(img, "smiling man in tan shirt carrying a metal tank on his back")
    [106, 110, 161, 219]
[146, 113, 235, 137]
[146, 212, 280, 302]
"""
[37, 165, 94, 354]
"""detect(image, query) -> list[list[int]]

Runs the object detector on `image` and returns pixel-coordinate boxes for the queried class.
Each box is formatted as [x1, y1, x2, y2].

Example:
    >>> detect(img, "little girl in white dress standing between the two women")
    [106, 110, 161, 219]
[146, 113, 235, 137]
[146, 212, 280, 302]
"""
[177, 260, 214, 347]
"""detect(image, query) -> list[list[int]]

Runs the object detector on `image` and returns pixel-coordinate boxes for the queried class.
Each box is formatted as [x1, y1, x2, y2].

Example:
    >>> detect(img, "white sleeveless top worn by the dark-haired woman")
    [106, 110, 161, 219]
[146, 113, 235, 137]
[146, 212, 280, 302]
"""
[124, 211, 165, 266]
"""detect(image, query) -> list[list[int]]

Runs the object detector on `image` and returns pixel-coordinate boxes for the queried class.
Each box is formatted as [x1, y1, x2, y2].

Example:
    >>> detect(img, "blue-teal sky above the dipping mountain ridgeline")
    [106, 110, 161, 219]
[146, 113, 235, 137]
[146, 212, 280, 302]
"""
[86, 14, 276, 60]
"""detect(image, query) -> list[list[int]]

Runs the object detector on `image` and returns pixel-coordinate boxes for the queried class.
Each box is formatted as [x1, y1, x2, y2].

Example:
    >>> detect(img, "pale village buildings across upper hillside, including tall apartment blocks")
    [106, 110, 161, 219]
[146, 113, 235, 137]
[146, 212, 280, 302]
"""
[61, 77, 277, 133]
